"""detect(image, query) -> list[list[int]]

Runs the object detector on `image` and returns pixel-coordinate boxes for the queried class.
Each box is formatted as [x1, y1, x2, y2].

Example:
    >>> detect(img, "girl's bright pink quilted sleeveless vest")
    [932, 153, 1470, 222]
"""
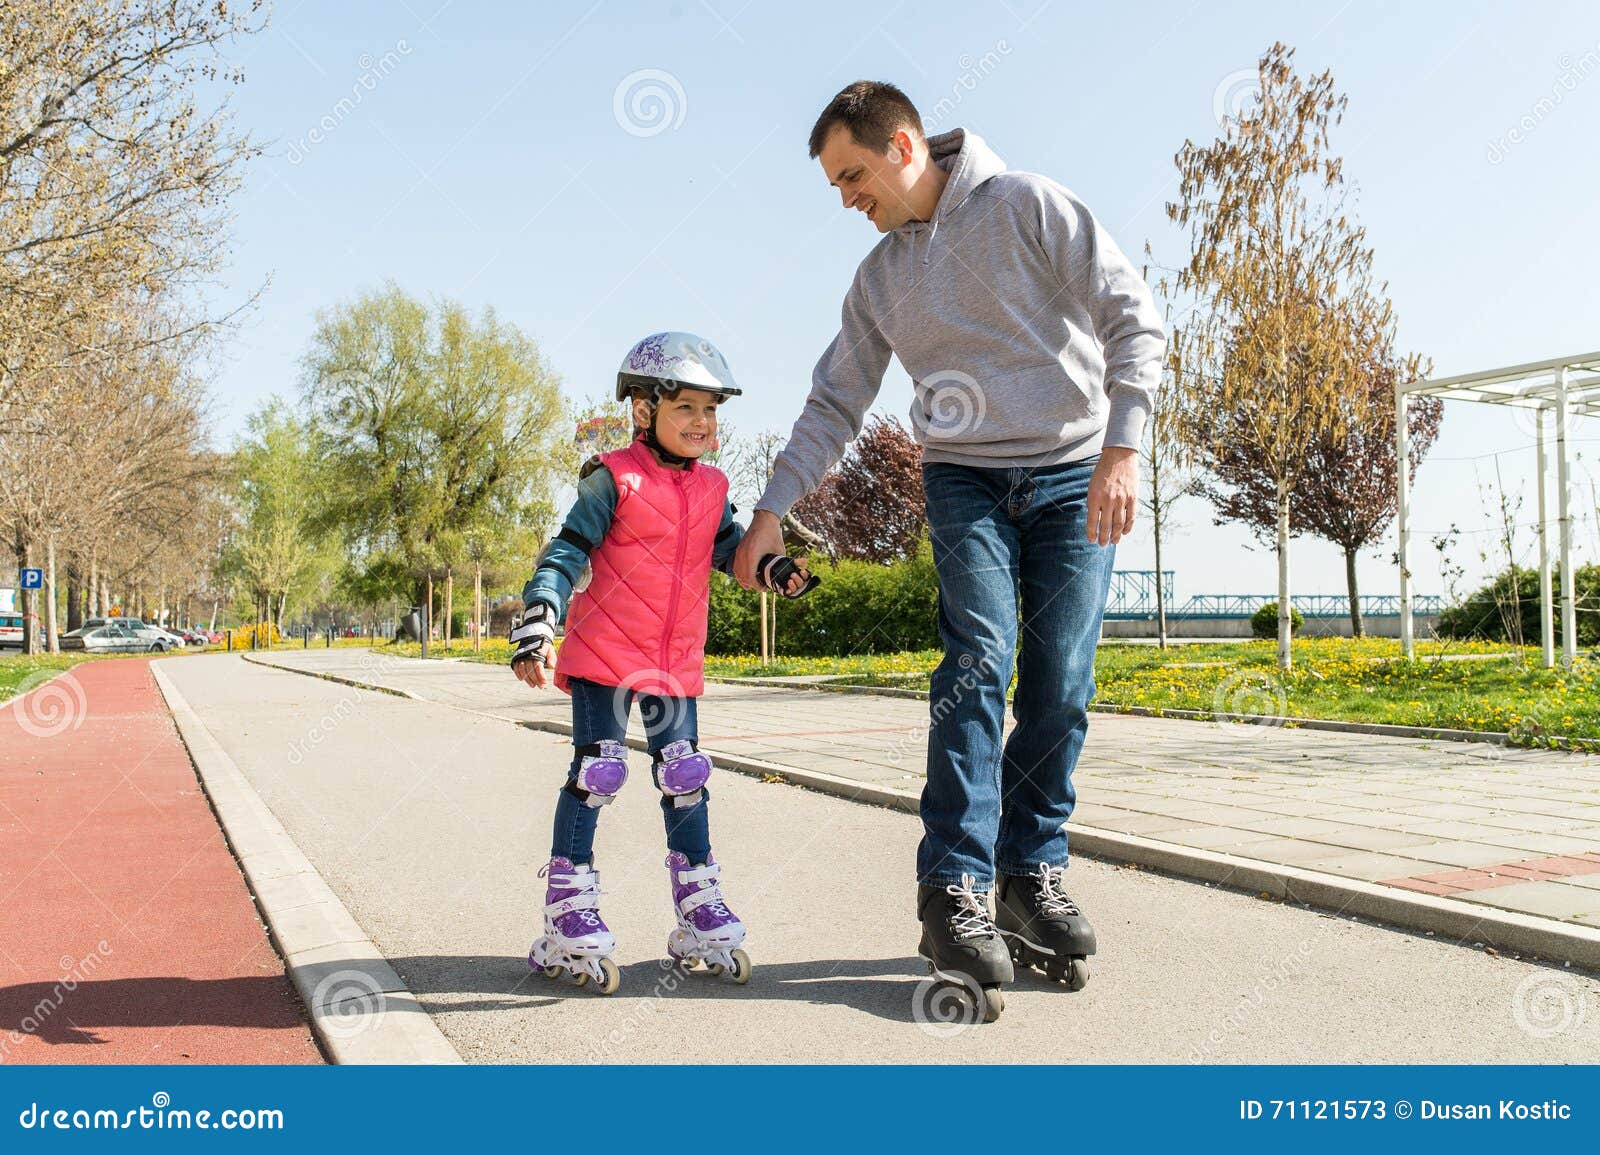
[555, 442, 728, 697]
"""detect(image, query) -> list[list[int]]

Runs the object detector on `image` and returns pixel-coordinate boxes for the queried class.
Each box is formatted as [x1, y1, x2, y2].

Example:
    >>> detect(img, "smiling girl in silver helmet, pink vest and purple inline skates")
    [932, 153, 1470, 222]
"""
[510, 333, 814, 995]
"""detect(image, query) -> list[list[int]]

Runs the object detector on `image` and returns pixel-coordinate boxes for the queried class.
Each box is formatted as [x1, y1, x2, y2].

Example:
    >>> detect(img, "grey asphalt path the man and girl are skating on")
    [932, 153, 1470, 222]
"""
[152, 654, 1600, 1062]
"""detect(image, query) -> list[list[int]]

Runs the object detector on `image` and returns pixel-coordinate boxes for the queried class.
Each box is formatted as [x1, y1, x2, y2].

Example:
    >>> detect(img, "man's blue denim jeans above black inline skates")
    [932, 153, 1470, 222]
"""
[917, 456, 1115, 889]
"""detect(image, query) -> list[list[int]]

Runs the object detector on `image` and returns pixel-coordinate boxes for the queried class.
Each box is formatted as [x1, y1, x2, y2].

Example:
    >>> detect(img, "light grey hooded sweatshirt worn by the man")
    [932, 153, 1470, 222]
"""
[757, 128, 1166, 517]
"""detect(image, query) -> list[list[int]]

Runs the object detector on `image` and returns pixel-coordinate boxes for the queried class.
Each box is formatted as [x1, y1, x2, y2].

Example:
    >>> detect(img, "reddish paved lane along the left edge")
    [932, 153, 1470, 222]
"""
[0, 659, 322, 1062]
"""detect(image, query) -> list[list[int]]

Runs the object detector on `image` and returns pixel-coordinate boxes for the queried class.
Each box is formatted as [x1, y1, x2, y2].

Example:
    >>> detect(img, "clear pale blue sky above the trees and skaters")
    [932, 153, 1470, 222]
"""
[200, 0, 1600, 598]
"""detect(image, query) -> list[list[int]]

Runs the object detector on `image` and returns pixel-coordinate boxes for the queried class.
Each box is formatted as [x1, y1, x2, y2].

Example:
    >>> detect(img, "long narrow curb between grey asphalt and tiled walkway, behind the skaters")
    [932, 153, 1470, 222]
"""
[243, 659, 1600, 973]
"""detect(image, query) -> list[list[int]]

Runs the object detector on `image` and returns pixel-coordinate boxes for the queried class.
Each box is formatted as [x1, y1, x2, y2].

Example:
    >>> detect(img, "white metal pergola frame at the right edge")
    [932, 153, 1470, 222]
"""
[1395, 352, 1600, 669]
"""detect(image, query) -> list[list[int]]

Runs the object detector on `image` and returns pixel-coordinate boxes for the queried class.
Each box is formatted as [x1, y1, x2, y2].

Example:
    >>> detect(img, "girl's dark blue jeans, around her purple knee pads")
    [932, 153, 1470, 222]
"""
[550, 678, 710, 865]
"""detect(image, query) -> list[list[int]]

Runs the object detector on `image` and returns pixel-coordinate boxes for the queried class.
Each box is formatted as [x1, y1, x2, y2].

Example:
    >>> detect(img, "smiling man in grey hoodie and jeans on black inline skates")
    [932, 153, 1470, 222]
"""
[734, 82, 1165, 1019]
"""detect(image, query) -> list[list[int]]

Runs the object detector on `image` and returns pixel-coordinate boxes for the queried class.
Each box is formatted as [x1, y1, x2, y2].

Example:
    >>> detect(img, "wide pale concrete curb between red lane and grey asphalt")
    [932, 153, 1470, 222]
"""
[150, 662, 461, 1064]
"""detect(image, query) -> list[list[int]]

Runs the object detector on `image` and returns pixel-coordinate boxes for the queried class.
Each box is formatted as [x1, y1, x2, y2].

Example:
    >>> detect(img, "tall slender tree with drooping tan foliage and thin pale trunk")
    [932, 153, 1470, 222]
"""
[1166, 43, 1392, 669]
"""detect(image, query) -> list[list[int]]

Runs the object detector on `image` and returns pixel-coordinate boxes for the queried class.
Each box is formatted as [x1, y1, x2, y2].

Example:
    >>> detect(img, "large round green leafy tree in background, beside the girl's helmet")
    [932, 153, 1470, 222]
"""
[302, 285, 573, 600]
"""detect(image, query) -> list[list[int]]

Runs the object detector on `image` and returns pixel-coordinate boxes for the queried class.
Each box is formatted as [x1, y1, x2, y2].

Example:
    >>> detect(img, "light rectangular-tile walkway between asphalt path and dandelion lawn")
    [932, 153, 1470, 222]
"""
[264, 649, 1600, 928]
